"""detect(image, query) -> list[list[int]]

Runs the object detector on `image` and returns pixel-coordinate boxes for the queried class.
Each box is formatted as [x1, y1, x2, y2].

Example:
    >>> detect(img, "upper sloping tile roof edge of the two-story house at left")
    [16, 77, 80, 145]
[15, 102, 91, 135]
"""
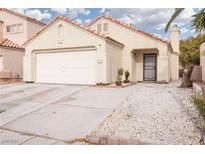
[0, 8, 46, 26]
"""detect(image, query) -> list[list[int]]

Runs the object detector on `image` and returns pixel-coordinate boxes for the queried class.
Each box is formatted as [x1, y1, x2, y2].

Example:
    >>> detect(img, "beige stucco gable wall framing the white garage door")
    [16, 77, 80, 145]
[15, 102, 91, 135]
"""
[24, 19, 119, 83]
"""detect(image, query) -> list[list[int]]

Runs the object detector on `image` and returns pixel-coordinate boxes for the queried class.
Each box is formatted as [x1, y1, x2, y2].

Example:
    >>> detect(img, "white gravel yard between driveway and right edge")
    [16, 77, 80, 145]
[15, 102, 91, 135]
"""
[91, 82, 201, 144]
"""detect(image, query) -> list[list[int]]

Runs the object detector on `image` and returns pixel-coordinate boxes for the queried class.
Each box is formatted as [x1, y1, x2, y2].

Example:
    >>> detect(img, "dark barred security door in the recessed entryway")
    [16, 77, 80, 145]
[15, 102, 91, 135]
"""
[143, 54, 157, 81]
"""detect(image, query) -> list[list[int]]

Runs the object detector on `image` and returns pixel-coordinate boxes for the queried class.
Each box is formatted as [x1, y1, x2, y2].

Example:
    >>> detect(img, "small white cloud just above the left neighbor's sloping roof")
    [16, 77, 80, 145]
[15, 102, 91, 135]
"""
[25, 9, 51, 20]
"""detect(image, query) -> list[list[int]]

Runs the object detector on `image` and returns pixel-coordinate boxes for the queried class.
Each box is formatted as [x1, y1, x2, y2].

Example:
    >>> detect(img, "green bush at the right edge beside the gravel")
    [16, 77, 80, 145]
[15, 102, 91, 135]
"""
[192, 96, 205, 119]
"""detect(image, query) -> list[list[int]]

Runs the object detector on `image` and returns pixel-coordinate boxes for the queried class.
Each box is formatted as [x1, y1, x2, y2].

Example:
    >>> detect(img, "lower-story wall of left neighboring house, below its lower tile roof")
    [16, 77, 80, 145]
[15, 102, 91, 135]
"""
[0, 48, 24, 78]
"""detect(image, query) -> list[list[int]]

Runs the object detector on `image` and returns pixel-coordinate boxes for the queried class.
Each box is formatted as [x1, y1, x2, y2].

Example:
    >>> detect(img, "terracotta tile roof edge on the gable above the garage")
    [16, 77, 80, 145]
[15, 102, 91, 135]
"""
[23, 16, 124, 46]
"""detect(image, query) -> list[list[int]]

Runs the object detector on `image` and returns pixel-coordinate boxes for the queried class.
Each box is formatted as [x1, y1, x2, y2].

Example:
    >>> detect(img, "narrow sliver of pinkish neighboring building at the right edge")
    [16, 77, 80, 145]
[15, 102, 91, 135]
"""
[200, 42, 205, 82]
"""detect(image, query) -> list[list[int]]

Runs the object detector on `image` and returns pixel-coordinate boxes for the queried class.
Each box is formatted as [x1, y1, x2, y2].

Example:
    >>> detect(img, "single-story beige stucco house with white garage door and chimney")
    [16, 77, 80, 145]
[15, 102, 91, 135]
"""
[24, 16, 179, 84]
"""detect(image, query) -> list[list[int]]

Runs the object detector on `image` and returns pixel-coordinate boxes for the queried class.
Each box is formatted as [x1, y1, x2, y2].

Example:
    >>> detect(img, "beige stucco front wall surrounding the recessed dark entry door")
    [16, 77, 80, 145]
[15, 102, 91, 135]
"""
[90, 18, 170, 81]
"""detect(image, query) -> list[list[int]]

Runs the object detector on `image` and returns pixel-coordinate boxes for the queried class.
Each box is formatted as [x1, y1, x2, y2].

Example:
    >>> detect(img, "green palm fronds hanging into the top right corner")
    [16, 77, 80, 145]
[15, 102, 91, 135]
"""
[165, 8, 205, 33]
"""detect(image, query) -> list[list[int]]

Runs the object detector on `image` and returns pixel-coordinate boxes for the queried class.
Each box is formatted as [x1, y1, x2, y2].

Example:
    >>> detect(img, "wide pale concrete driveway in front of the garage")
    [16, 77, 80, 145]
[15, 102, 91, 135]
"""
[0, 83, 133, 144]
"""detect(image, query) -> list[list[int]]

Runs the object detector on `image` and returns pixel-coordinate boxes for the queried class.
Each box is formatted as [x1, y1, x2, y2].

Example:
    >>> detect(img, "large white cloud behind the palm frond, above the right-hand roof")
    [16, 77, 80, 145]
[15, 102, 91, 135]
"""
[109, 8, 194, 30]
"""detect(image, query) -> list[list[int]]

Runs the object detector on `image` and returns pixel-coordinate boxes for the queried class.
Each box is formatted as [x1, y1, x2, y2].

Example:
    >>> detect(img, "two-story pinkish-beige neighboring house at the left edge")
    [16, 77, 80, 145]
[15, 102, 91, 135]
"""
[0, 8, 45, 78]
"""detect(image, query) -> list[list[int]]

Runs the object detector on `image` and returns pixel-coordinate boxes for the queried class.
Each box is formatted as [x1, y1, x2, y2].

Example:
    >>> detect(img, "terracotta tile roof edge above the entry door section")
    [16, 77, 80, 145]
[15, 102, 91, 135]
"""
[87, 16, 170, 44]
